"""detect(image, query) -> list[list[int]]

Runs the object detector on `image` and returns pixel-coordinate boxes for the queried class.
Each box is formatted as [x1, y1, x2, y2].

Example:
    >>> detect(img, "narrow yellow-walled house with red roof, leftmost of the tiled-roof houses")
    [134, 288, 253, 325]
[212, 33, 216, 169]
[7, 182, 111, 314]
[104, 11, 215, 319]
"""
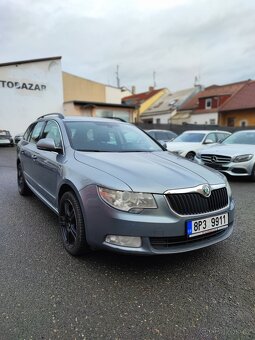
[122, 87, 168, 122]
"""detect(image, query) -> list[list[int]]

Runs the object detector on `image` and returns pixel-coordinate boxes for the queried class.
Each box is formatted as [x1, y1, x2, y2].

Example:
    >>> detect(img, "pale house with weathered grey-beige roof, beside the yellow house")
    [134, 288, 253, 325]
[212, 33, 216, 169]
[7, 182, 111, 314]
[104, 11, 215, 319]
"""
[140, 88, 198, 124]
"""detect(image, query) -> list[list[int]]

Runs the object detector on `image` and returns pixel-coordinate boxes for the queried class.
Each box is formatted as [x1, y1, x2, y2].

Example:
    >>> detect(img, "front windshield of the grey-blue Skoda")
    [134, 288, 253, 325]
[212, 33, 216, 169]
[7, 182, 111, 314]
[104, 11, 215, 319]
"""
[65, 121, 163, 152]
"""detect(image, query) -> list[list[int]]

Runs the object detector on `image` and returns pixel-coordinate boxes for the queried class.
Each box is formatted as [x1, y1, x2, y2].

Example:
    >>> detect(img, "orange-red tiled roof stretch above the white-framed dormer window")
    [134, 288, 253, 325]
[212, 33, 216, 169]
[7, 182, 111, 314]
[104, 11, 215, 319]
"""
[179, 80, 250, 111]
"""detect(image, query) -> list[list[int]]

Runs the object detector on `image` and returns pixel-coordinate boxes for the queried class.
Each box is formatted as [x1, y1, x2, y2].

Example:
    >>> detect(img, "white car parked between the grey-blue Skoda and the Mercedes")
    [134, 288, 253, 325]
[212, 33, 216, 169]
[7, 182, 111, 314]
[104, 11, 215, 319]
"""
[166, 130, 231, 160]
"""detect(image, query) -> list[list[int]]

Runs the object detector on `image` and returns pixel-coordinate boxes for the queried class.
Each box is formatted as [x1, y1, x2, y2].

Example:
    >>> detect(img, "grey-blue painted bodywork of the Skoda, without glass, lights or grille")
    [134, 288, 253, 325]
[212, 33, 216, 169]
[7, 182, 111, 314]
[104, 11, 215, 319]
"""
[17, 118, 234, 255]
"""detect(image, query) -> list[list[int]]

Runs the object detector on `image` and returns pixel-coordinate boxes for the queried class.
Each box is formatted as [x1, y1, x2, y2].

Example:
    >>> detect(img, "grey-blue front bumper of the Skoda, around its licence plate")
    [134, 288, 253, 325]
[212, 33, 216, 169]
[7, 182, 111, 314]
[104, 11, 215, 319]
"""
[80, 186, 235, 255]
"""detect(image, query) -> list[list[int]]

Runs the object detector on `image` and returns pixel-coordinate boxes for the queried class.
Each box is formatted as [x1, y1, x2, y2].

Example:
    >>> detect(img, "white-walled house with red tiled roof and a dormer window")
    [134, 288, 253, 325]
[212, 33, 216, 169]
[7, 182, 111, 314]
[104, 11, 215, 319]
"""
[178, 80, 249, 125]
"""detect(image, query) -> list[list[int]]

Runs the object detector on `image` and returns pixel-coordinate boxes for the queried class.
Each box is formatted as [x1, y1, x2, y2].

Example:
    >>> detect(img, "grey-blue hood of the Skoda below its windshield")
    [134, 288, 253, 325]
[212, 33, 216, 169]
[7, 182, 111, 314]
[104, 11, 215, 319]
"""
[75, 151, 224, 193]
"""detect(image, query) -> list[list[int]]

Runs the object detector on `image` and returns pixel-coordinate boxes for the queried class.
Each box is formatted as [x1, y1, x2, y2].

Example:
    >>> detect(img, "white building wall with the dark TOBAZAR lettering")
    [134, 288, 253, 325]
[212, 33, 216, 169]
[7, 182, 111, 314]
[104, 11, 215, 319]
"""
[0, 59, 63, 135]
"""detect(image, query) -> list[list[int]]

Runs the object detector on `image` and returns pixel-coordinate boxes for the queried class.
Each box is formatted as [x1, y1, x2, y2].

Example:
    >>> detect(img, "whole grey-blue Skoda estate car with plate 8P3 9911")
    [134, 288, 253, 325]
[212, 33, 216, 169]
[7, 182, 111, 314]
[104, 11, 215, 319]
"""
[17, 114, 234, 255]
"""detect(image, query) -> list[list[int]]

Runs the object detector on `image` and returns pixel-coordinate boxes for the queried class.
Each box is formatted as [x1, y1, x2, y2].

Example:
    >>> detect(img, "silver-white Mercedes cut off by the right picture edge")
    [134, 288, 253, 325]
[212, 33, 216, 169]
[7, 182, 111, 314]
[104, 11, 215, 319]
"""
[195, 130, 255, 181]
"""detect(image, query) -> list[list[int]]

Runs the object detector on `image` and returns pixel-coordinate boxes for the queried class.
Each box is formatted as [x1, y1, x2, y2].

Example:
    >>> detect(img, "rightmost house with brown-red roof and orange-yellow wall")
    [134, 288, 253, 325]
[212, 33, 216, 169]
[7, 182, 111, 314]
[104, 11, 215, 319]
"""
[219, 81, 255, 127]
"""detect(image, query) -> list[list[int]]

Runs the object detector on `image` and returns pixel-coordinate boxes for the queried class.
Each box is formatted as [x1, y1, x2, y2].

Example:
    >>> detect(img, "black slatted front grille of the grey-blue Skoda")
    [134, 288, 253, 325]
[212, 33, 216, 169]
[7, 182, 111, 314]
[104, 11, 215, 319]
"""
[166, 188, 228, 215]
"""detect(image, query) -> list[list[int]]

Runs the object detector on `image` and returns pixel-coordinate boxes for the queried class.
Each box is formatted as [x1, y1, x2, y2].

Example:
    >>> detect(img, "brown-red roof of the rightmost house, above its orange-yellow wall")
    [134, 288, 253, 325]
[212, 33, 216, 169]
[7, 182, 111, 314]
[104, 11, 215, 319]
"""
[219, 80, 255, 112]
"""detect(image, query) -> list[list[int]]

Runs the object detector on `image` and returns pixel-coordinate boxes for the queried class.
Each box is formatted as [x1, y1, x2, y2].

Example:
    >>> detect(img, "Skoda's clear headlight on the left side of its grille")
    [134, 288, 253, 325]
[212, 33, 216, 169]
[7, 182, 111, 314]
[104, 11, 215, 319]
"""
[98, 187, 157, 213]
